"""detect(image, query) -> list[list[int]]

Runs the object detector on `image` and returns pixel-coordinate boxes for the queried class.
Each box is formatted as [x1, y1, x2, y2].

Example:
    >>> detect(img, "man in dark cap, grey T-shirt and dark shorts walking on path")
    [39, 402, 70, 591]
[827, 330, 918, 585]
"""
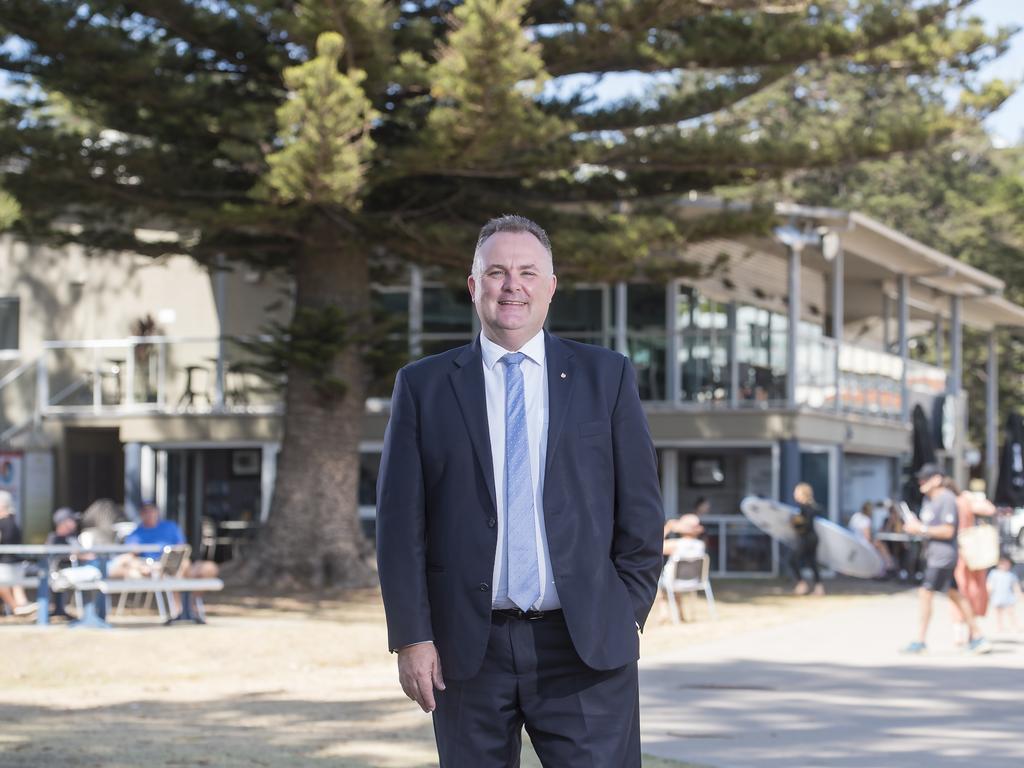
[903, 464, 992, 653]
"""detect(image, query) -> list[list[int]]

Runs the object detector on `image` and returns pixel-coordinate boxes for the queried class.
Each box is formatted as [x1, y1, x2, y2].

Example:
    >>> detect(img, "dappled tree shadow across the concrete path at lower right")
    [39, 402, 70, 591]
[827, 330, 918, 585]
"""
[641, 655, 1024, 768]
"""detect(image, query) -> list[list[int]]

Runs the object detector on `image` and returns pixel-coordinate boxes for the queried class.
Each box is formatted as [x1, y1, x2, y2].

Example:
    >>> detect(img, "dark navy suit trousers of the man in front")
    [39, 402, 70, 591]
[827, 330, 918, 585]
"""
[434, 611, 640, 768]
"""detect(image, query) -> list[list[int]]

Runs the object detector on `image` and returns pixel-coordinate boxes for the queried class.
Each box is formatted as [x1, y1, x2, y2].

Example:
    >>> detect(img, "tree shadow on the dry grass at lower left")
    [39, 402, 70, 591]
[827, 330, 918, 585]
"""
[0, 693, 696, 768]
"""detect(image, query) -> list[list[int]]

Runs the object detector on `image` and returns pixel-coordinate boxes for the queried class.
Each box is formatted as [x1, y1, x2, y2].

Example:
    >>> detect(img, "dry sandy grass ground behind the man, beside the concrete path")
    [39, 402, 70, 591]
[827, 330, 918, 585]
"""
[0, 582, 886, 768]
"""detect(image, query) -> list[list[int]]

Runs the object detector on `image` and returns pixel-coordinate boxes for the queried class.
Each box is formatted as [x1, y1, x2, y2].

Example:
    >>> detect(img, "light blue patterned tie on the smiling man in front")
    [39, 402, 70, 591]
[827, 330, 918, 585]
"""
[502, 352, 541, 610]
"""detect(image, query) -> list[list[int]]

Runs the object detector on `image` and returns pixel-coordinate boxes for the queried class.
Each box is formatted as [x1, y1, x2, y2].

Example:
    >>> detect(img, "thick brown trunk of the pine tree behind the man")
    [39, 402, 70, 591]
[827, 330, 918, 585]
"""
[231, 220, 374, 590]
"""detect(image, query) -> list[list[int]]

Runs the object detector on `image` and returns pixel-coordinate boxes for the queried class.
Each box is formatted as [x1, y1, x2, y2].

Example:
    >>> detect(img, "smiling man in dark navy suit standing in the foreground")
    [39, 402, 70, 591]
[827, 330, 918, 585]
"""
[377, 216, 665, 768]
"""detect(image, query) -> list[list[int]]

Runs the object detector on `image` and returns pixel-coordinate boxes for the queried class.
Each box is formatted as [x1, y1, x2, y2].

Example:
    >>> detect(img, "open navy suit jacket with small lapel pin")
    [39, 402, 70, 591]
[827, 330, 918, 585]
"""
[377, 334, 665, 680]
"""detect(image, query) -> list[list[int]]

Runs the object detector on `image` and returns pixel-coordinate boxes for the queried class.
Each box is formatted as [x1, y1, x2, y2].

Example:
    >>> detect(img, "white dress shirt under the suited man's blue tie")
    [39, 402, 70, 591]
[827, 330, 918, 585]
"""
[480, 331, 561, 610]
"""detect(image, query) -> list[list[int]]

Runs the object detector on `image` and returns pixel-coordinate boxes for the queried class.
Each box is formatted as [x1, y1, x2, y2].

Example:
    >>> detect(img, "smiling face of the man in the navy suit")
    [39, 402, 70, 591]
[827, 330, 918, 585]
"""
[469, 232, 557, 351]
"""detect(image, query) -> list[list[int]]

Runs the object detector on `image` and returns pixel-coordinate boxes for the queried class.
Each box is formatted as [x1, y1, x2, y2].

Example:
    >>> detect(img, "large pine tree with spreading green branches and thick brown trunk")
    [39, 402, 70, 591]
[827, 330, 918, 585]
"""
[0, 0, 1006, 584]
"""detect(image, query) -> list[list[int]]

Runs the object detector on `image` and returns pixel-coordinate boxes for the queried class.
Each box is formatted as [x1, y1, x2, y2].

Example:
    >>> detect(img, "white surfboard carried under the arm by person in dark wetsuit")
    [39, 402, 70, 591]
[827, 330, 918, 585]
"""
[739, 497, 885, 579]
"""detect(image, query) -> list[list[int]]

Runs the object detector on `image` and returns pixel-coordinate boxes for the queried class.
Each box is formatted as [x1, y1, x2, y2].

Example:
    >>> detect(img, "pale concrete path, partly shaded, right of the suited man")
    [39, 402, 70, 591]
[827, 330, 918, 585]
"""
[640, 592, 1024, 768]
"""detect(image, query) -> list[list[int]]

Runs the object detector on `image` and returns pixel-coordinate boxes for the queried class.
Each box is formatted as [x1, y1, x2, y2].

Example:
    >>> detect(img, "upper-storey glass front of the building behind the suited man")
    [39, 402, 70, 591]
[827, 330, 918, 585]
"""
[371, 270, 946, 419]
